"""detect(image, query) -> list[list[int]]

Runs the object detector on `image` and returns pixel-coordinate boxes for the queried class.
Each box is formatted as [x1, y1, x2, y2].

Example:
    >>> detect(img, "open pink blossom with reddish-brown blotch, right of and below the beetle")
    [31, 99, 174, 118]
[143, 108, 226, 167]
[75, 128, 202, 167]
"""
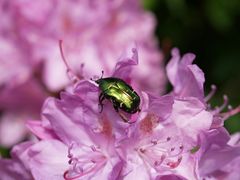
[117, 95, 212, 179]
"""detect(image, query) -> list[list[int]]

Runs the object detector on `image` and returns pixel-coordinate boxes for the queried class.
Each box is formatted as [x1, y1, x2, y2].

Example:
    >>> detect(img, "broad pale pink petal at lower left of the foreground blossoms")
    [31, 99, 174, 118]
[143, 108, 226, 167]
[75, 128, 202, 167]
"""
[14, 140, 68, 180]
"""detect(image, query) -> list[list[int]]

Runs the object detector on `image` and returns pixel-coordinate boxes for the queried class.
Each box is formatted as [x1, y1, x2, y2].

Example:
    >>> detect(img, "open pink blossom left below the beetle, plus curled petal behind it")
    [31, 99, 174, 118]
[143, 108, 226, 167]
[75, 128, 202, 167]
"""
[1, 46, 141, 179]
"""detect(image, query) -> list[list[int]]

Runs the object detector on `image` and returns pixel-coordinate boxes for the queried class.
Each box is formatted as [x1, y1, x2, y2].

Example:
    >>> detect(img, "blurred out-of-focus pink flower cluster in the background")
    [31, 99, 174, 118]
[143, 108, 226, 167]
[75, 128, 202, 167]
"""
[0, 0, 165, 147]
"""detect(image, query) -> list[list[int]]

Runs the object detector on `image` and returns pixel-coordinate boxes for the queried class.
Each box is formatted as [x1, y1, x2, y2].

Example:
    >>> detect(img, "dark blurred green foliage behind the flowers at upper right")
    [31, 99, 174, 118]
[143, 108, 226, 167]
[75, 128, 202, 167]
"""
[142, 0, 240, 133]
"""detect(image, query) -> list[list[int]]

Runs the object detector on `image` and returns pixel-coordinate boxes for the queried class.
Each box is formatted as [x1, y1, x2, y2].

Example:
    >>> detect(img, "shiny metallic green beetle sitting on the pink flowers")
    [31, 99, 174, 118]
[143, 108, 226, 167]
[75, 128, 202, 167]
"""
[92, 74, 140, 122]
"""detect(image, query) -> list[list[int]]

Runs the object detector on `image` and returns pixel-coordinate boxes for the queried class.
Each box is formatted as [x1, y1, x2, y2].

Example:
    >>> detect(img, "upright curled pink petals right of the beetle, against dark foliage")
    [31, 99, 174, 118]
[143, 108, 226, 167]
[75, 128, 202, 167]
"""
[166, 48, 205, 102]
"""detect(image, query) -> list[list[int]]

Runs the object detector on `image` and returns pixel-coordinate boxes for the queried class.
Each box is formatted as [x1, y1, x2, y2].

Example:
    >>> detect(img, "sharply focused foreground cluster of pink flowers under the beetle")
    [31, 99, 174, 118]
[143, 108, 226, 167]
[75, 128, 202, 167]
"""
[0, 48, 240, 180]
